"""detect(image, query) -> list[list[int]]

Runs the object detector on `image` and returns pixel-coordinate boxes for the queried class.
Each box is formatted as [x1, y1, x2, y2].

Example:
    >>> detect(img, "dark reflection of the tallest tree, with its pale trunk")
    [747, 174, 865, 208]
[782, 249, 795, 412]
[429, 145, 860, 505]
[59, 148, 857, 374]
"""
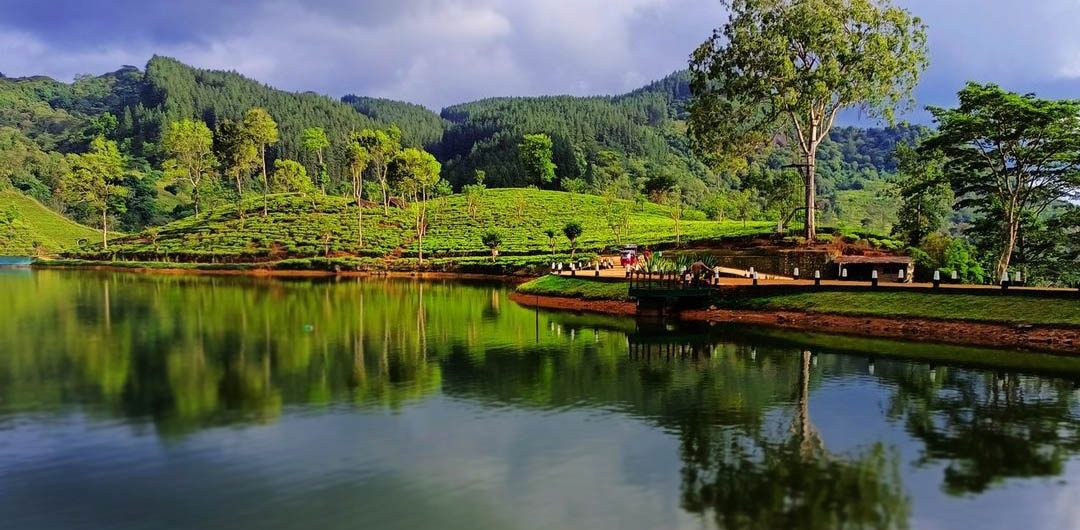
[680, 352, 910, 529]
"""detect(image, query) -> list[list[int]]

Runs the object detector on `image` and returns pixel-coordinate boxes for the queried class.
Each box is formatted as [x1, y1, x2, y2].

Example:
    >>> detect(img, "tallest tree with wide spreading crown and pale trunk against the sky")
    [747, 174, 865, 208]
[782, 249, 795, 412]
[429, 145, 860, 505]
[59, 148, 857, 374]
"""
[689, 0, 927, 240]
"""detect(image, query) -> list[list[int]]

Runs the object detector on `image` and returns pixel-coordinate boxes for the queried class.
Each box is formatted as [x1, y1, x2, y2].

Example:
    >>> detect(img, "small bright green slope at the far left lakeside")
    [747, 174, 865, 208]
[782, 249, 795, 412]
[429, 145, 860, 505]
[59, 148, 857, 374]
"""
[0, 190, 102, 256]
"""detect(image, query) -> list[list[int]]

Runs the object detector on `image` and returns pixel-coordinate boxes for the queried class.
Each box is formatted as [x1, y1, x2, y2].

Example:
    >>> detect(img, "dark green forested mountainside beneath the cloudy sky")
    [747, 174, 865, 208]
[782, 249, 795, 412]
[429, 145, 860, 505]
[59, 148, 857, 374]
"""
[0, 57, 919, 239]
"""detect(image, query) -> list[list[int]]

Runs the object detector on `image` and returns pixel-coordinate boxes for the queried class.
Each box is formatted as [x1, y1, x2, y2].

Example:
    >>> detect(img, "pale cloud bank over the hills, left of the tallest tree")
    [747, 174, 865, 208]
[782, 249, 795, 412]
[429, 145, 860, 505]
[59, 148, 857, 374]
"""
[0, 0, 723, 108]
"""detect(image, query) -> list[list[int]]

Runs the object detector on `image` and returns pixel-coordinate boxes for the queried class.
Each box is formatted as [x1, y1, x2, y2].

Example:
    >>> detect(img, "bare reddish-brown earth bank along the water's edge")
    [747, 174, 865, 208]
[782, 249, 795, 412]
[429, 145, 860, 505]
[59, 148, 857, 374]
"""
[510, 293, 1080, 355]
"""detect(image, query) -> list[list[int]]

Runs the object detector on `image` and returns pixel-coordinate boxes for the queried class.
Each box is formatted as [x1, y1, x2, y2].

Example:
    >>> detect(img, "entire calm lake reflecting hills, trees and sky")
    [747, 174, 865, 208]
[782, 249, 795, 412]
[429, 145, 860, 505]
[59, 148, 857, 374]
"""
[0, 270, 1080, 530]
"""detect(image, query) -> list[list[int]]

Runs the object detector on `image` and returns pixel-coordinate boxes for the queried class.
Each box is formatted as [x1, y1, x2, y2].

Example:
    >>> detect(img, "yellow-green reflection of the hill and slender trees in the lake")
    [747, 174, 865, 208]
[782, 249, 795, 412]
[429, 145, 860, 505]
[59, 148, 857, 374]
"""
[0, 272, 615, 434]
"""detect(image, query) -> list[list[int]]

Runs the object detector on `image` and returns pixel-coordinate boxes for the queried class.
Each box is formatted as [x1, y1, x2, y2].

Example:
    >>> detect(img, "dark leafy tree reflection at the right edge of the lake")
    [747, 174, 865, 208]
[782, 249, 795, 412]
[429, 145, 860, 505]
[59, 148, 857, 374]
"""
[877, 365, 1080, 494]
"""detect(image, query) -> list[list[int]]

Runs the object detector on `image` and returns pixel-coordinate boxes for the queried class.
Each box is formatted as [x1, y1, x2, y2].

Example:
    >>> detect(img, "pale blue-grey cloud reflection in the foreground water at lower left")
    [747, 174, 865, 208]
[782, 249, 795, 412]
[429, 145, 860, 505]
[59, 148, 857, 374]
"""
[0, 397, 700, 529]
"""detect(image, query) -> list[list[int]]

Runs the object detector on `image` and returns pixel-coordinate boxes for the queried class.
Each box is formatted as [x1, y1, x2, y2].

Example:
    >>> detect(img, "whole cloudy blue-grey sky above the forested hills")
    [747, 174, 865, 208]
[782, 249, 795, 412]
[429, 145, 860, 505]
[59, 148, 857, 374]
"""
[0, 0, 1080, 121]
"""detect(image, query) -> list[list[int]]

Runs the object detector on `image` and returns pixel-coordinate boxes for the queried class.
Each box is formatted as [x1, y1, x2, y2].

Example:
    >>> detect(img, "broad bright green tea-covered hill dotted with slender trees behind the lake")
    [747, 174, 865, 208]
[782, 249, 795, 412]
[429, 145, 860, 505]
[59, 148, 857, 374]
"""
[82, 189, 772, 263]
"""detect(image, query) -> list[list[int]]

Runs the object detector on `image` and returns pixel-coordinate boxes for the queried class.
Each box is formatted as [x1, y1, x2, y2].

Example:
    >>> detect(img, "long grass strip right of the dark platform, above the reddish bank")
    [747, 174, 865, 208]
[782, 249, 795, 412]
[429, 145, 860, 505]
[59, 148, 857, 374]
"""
[717, 291, 1080, 326]
